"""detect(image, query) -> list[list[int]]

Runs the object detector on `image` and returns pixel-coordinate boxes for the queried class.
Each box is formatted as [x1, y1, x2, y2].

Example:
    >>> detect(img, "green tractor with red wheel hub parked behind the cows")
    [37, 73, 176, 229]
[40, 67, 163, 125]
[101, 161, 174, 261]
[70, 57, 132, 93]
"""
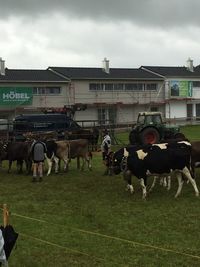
[129, 112, 185, 145]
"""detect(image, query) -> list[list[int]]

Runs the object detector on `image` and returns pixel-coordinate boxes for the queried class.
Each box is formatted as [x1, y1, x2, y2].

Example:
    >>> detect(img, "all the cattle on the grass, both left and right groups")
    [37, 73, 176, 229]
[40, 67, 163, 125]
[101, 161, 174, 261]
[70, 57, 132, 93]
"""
[0, 132, 200, 199]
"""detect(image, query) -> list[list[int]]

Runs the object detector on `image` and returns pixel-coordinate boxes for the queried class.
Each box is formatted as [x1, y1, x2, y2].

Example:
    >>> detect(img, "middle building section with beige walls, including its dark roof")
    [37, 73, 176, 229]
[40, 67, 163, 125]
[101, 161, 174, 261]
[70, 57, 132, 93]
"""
[49, 63, 165, 124]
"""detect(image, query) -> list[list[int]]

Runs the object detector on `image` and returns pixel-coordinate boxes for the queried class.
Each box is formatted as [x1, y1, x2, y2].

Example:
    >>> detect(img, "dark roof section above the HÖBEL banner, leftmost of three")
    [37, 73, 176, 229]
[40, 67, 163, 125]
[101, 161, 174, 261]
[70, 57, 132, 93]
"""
[0, 68, 67, 82]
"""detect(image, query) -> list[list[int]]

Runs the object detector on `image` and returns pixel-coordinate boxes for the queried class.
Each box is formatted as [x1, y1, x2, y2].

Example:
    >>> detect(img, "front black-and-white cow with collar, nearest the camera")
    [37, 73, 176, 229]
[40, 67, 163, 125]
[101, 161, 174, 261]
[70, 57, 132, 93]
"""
[113, 141, 199, 199]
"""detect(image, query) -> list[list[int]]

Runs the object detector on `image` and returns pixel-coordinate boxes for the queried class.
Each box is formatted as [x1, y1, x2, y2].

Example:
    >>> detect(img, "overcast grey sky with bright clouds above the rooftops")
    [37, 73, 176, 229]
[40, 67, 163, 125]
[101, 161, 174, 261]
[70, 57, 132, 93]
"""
[0, 0, 200, 69]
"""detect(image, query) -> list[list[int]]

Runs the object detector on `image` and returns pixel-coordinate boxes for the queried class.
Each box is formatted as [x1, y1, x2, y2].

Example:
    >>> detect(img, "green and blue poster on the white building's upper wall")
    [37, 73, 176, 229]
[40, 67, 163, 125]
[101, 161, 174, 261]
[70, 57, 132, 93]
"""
[170, 81, 192, 97]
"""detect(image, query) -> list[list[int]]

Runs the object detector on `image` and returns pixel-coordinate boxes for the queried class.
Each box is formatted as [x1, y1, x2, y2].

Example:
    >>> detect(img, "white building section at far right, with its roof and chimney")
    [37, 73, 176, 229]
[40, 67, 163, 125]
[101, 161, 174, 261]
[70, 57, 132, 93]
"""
[141, 59, 200, 120]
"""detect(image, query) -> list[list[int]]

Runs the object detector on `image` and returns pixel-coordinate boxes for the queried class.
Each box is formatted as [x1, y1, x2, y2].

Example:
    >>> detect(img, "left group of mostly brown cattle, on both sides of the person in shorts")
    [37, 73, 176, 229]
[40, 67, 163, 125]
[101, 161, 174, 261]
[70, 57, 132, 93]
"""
[0, 139, 92, 175]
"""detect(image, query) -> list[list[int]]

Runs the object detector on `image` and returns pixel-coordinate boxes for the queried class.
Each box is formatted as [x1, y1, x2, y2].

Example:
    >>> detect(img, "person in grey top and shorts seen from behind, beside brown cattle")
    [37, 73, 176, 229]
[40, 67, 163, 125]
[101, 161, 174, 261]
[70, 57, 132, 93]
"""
[31, 136, 47, 182]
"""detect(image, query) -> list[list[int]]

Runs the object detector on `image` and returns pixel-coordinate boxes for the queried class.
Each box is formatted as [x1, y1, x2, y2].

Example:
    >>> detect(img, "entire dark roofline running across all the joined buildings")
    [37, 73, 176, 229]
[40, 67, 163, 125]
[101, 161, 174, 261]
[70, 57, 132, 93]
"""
[0, 66, 200, 83]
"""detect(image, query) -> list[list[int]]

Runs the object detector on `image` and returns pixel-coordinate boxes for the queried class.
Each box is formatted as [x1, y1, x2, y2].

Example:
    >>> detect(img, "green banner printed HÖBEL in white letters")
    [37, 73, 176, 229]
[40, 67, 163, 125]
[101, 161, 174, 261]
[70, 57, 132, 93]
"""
[0, 87, 33, 106]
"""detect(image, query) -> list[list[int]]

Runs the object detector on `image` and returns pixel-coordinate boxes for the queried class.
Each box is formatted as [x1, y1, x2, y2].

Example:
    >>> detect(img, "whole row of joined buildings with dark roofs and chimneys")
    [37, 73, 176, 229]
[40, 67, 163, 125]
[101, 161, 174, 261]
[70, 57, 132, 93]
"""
[0, 56, 200, 125]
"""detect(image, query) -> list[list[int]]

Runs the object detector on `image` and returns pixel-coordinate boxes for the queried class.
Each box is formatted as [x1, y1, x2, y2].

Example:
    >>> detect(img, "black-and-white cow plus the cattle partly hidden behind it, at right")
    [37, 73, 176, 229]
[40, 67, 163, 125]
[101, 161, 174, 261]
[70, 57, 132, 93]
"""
[105, 138, 200, 199]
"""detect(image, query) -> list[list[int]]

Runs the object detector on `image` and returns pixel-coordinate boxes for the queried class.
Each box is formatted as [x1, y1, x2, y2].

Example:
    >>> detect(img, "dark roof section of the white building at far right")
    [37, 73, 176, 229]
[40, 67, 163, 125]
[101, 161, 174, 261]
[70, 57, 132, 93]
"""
[140, 66, 200, 78]
